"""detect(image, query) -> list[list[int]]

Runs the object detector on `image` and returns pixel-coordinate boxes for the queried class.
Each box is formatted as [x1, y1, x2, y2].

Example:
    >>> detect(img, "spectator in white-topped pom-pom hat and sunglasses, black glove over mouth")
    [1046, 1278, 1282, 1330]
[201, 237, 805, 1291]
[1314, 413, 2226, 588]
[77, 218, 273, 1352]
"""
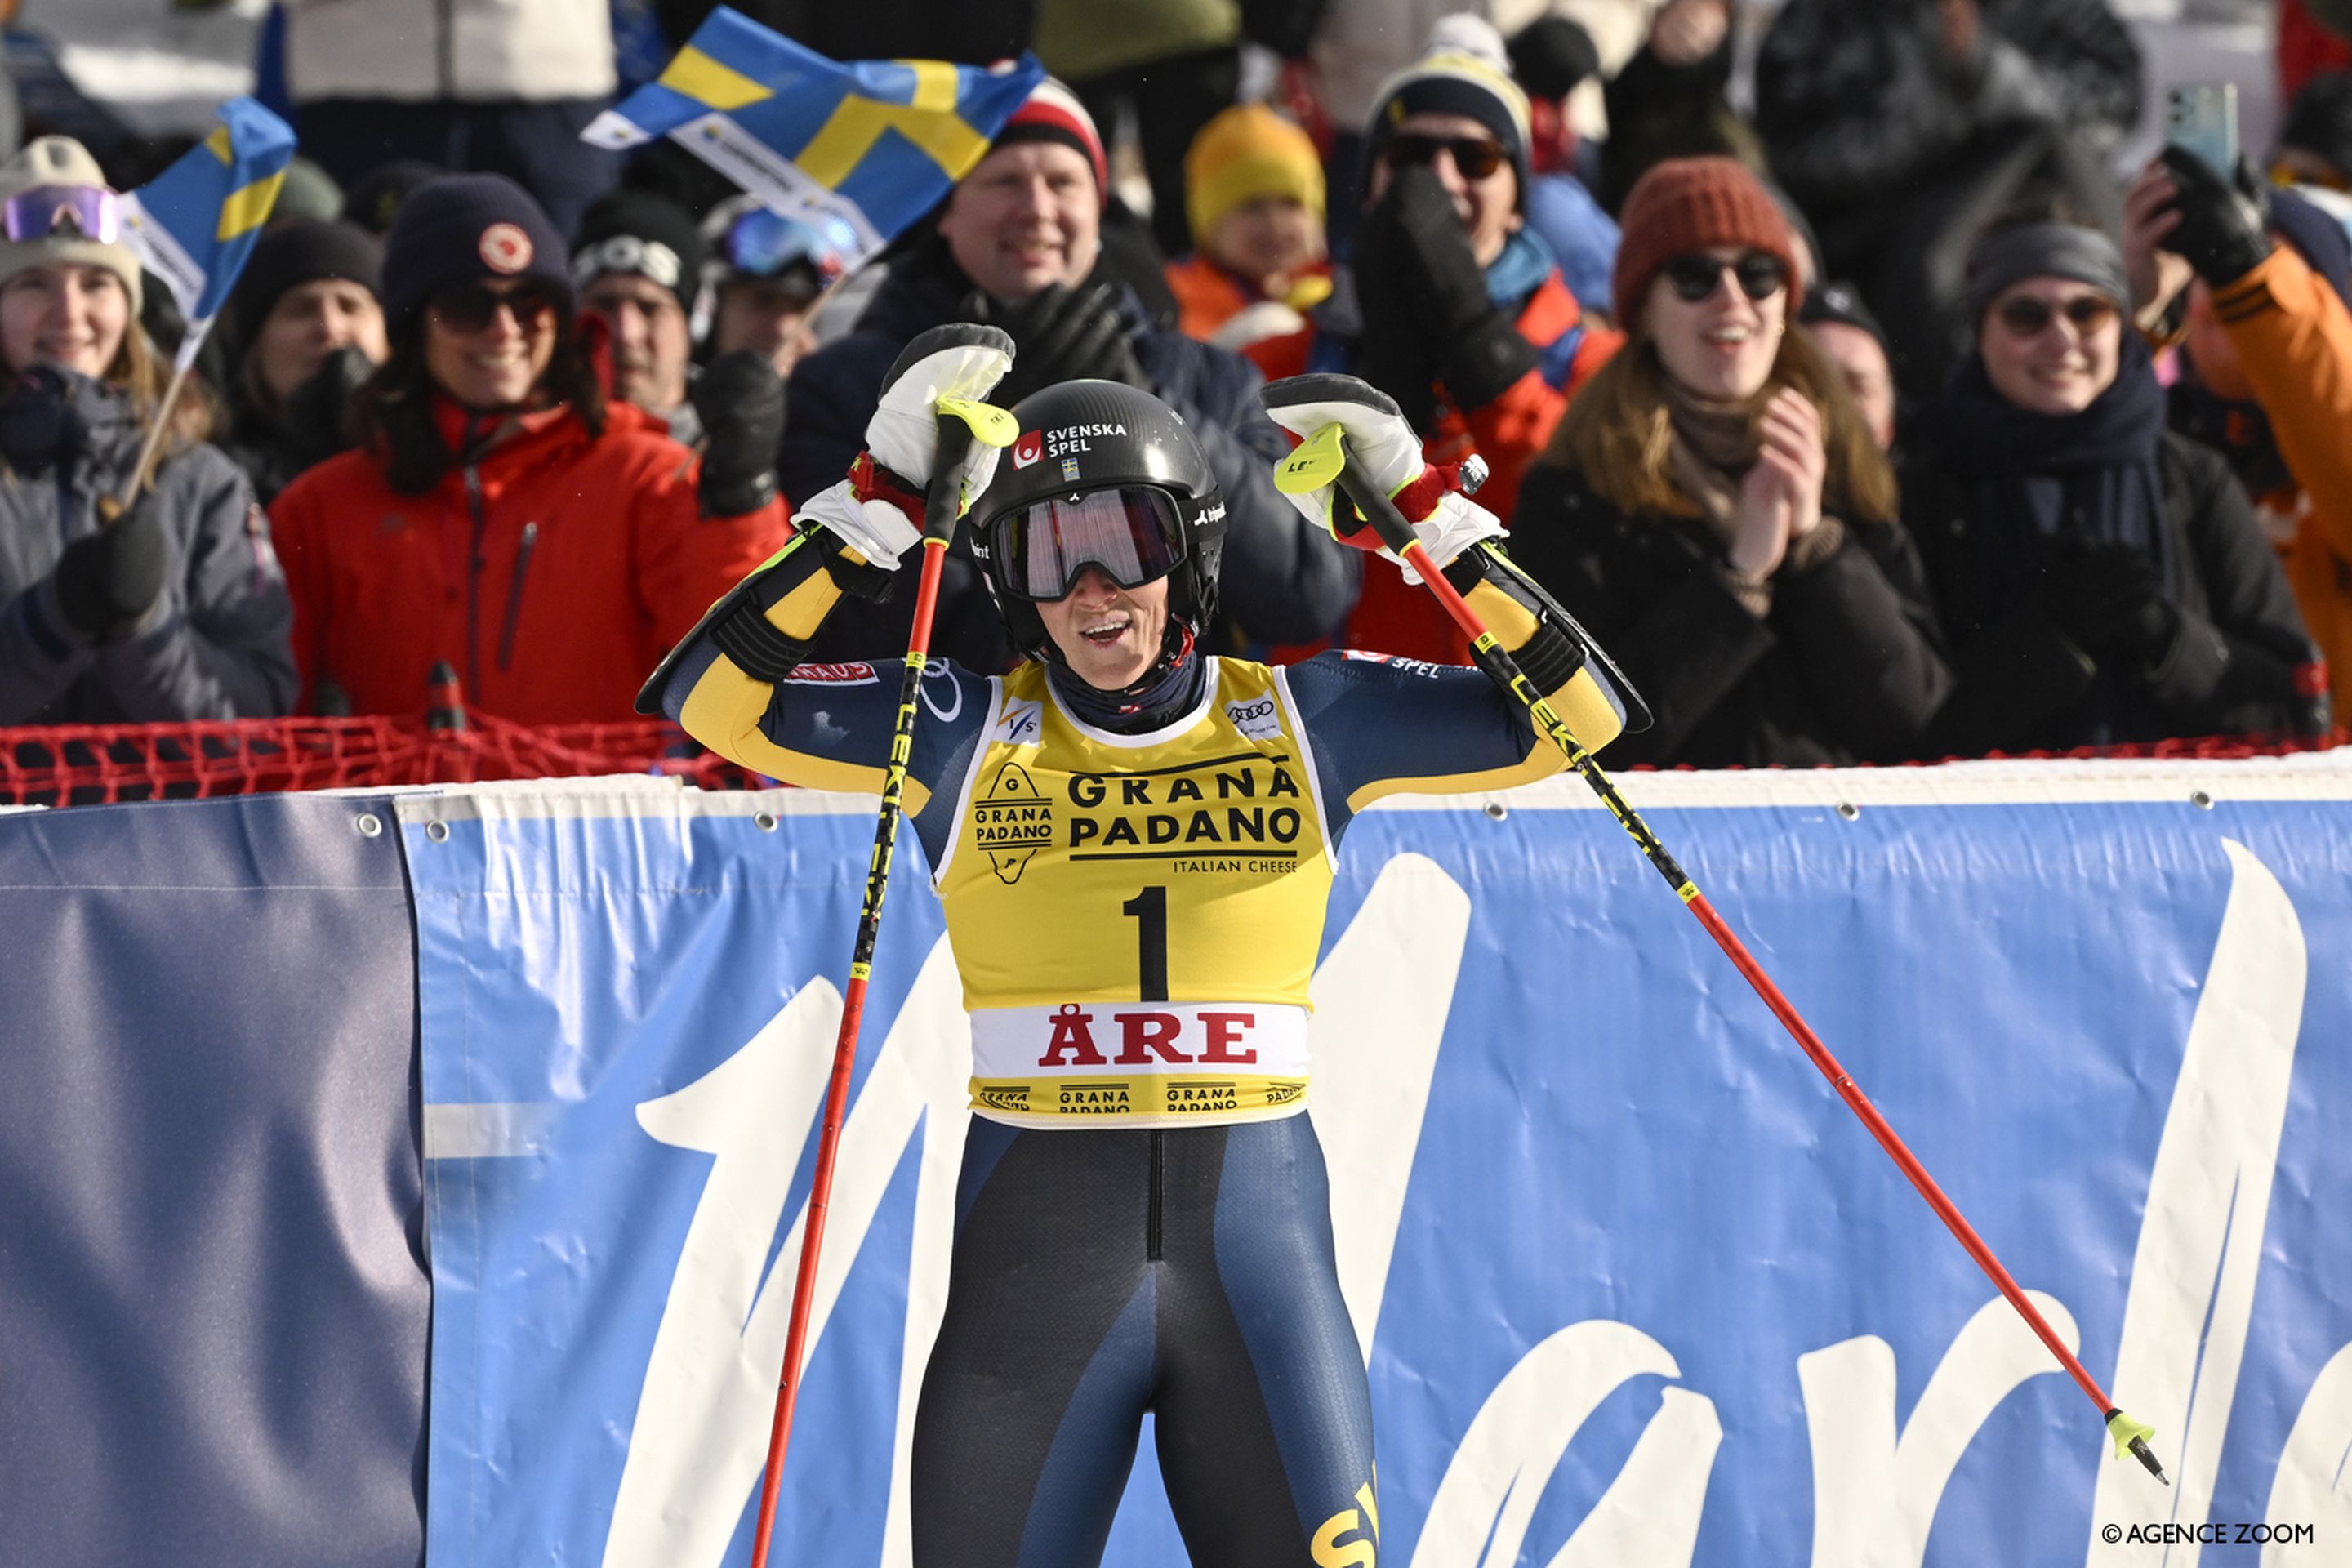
[1246, 16, 1623, 663]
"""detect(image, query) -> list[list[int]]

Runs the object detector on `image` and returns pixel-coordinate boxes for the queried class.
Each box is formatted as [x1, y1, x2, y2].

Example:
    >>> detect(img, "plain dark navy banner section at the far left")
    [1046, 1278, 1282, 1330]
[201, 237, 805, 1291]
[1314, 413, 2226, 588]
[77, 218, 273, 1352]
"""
[0, 795, 428, 1568]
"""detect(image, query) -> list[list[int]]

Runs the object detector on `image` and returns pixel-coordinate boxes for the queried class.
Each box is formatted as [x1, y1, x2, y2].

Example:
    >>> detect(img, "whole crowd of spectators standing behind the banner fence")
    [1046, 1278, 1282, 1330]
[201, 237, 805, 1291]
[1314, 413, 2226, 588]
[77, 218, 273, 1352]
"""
[0, 0, 2352, 766]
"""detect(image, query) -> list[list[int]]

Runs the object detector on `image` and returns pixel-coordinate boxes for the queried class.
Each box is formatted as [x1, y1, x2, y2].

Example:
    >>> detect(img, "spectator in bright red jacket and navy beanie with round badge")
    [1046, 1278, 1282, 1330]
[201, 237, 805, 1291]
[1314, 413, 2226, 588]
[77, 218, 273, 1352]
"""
[273, 174, 788, 724]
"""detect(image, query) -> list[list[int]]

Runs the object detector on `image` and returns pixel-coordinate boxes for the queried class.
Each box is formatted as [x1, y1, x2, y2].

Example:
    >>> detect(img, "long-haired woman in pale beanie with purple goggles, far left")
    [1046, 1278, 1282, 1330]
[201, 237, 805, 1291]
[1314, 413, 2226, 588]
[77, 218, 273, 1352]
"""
[0, 136, 294, 724]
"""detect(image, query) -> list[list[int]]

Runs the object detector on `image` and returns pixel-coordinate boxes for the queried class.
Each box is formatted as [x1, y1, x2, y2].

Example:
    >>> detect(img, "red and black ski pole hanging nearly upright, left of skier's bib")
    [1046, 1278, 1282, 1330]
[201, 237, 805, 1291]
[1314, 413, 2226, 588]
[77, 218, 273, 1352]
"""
[751, 411, 971, 1568]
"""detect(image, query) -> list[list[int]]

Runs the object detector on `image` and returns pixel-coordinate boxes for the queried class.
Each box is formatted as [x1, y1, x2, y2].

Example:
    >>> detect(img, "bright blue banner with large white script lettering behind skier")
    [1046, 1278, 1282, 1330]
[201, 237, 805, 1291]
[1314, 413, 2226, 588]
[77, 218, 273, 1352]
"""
[402, 764, 2352, 1568]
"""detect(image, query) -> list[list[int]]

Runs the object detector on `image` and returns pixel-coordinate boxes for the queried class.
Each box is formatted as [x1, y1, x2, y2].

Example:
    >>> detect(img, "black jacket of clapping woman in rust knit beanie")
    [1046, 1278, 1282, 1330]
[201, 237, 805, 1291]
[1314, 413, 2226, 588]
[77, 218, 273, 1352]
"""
[1510, 466, 1952, 768]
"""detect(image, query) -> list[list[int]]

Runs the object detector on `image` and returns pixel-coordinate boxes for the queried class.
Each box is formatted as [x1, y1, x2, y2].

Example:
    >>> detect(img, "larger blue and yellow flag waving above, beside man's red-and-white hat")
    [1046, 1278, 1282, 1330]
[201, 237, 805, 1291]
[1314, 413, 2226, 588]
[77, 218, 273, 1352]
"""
[581, 5, 1045, 256]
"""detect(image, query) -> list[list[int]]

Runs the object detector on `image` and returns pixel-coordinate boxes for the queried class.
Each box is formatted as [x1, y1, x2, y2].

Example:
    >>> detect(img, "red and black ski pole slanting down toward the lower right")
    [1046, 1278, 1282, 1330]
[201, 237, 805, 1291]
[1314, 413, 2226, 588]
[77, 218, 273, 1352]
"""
[1286, 425, 2171, 1486]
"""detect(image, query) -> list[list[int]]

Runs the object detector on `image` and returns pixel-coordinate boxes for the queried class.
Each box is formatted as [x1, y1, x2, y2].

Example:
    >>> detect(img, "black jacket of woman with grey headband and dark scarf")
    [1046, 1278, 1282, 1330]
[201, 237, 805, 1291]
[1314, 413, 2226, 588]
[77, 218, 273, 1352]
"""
[1903, 433, 2326, 755]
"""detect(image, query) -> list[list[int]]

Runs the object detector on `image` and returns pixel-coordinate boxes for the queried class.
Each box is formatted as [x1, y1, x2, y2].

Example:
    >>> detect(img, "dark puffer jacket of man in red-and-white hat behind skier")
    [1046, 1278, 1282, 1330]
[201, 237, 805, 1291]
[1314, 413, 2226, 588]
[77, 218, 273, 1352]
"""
[776, 244, 1362, 675]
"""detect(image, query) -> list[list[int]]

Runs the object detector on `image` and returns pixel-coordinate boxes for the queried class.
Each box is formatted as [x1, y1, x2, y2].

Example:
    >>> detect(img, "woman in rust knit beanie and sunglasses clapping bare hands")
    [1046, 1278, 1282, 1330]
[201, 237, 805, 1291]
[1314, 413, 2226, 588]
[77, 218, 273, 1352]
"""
[1510, 158, 1952, 766]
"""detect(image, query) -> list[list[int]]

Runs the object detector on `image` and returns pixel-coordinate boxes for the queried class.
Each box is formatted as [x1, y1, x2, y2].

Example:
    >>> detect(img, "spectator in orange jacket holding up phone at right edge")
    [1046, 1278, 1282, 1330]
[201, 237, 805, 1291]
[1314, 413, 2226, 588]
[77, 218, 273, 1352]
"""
[2127, 148, 2352, 724]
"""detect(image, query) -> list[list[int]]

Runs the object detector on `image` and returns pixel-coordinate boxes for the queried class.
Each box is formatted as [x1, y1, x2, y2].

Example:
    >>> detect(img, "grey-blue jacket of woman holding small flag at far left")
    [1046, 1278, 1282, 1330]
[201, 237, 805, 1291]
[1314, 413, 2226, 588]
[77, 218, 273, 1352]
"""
[0, 378, 294, 724]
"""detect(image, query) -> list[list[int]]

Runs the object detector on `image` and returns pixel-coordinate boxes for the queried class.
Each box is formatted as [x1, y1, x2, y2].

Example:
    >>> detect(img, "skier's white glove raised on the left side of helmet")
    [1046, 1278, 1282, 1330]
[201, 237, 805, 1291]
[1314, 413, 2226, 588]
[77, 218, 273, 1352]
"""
[800, 322, 1018, 571]
